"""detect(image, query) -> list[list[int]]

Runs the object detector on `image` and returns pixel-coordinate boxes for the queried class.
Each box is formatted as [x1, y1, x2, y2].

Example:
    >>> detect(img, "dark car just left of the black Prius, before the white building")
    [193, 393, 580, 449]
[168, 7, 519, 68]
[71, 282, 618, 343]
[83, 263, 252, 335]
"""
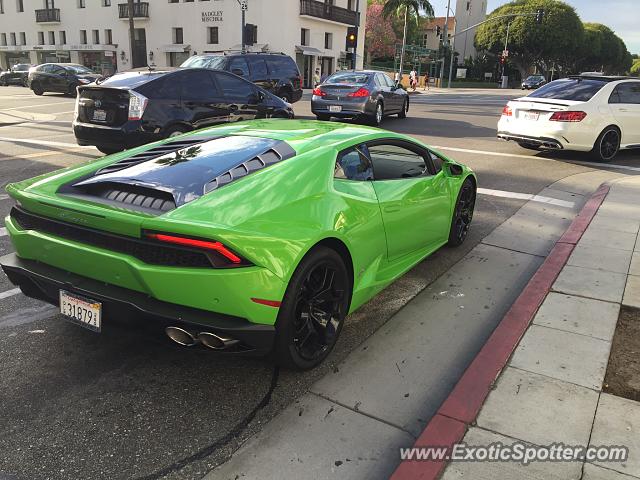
[28, 63, 101, 97]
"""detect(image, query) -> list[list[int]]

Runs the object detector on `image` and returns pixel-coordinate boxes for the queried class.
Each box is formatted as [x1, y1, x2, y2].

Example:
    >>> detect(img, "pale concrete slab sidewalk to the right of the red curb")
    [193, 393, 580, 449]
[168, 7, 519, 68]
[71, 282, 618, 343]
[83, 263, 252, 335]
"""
[402, 177, 640, 480]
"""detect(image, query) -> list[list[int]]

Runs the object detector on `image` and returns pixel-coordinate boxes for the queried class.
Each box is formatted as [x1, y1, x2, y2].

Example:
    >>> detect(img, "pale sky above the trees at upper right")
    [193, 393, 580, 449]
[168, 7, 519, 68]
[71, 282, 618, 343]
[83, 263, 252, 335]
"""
[430, 0, 640, 54]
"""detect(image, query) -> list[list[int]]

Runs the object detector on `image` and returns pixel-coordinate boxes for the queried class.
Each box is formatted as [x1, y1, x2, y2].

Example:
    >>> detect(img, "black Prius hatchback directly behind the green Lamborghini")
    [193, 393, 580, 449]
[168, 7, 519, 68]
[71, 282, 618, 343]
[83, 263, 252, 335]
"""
[73, 68, 293, 153]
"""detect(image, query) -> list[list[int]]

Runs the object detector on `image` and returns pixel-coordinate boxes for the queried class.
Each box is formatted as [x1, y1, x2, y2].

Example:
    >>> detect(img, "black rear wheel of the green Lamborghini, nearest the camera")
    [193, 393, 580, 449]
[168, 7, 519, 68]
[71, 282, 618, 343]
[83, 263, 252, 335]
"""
[274, 247, 351, 370]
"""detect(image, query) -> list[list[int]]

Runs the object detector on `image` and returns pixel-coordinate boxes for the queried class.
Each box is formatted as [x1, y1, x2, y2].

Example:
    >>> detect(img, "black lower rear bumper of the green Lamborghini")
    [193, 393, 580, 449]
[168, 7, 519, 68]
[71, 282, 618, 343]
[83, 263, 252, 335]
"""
[0, 254, 275, 354]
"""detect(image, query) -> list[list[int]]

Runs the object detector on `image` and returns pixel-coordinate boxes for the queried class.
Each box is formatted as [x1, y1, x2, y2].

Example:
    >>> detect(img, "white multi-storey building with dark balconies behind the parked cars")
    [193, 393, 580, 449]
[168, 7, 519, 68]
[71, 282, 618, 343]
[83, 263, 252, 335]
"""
[0, 0, 366, 86]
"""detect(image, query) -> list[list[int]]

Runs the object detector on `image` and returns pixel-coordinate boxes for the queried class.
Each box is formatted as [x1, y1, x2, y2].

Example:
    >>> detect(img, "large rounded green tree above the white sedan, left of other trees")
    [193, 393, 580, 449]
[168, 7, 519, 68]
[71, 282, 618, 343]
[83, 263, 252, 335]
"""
[475, 0, 584, 77]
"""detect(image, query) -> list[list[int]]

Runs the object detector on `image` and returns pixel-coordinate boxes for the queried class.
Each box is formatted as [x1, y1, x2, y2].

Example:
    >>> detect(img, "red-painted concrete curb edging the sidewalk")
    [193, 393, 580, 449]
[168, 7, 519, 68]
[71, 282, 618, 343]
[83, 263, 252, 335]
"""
[391, 184, 609, 480]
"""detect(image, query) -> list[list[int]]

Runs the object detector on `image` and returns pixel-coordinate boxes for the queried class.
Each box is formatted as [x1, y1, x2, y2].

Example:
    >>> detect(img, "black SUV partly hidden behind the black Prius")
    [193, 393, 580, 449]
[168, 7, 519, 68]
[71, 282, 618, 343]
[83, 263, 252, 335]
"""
[180, 53, 302, 103]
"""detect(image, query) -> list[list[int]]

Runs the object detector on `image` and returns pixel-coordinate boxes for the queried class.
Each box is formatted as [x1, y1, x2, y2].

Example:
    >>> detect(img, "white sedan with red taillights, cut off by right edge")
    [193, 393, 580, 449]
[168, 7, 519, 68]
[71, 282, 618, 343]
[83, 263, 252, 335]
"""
[498, 74, 640, 162]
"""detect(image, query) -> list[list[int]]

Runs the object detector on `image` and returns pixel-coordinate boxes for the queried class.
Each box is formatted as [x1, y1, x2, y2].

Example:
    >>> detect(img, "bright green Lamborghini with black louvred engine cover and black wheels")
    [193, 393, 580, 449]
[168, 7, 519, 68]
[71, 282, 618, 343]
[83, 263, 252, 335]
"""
[0, 119, 476, 369]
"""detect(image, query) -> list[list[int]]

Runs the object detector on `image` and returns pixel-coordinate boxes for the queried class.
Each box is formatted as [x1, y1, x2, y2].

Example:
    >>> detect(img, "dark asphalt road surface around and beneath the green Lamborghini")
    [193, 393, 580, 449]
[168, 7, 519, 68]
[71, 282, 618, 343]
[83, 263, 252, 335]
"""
[0, 87, 640, 480]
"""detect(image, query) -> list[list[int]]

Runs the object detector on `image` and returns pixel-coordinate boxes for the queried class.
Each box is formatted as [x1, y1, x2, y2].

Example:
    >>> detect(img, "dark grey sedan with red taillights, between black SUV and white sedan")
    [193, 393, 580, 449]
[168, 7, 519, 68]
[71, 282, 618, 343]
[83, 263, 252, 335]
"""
[311, 70, 409, 126]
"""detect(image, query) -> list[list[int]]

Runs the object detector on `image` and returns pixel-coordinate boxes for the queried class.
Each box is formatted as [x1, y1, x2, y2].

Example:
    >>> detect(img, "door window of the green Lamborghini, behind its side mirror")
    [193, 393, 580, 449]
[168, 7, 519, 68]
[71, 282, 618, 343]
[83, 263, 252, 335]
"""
[369, 144, 428, 180]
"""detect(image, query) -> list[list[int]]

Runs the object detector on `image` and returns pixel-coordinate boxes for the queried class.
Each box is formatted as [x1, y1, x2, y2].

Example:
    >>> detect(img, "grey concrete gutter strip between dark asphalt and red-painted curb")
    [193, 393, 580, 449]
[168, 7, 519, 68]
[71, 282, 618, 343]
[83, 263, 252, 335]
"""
[206, 172, 624, 480]
